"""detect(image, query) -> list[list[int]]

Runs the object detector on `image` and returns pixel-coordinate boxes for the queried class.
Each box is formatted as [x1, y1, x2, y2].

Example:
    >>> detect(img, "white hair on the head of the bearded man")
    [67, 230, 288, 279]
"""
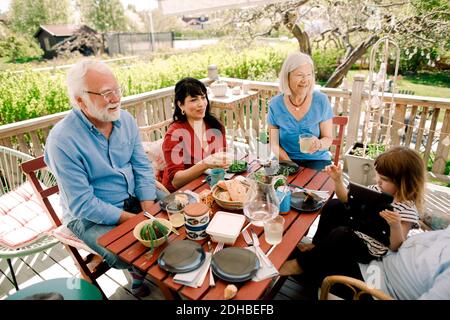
[67, 60, 113, 109]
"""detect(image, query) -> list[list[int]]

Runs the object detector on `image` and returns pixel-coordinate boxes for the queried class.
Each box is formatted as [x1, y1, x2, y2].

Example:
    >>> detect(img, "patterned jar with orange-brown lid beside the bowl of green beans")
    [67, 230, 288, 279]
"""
[184, 202, 209, 240]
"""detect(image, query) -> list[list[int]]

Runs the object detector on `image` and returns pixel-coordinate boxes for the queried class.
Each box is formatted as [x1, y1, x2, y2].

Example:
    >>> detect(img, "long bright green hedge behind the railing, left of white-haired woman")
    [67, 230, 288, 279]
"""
[0, 45, 295, 125]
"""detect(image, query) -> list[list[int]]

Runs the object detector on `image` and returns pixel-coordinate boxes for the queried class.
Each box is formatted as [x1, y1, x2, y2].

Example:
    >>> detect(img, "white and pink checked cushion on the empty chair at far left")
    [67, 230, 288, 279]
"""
[0, 182, 61, 249]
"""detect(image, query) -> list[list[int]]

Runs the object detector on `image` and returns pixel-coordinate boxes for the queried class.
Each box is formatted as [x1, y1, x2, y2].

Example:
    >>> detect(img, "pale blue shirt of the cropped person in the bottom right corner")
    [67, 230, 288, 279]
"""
[360, 226, 450, 300]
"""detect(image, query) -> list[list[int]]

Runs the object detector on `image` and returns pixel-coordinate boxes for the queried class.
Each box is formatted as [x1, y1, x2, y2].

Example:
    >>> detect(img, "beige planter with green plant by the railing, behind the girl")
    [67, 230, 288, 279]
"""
[345, 142, 386, 186]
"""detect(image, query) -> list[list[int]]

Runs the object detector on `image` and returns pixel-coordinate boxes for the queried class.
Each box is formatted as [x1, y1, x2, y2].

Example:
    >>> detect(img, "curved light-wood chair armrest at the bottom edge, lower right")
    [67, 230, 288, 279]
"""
[319, 275, 393, 300]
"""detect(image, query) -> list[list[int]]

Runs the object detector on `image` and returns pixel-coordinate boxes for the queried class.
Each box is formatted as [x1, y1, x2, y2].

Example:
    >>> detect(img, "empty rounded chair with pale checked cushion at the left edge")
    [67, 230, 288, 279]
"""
[0, 146, 59, 290]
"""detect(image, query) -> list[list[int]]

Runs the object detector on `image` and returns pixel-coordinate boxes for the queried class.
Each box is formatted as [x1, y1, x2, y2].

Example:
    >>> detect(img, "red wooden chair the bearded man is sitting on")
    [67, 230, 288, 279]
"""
[21, 156, 110, 299]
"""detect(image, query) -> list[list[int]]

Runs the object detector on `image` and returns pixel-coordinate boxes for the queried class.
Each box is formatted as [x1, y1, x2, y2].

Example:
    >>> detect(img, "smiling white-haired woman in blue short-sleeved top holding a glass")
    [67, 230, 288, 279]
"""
[267, 52, 333, 170]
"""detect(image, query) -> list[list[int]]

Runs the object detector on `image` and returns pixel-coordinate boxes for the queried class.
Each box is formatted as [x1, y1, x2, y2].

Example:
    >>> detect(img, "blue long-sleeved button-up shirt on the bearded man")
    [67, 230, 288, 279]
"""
[44, 109, 155, 225]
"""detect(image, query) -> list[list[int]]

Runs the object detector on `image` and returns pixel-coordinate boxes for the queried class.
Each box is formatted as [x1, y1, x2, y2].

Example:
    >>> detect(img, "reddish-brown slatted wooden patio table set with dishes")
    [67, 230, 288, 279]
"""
[98, 161, 334, 300]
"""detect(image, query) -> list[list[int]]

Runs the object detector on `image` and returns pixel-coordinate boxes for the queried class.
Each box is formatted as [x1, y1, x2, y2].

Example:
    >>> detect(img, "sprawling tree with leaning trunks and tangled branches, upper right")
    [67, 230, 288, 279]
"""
[223, 0, 450, 87]
